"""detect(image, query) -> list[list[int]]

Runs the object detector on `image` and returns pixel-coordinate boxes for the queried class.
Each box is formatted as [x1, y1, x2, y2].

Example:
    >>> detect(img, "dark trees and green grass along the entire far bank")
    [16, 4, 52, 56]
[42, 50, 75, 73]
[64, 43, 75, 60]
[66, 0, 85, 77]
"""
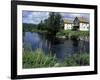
[23, 12, 89, 38]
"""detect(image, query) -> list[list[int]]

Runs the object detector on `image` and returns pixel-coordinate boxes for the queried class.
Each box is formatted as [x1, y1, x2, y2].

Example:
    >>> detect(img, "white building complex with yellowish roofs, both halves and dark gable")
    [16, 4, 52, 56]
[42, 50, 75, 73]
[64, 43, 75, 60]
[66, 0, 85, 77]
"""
[64, 17, 90, 31]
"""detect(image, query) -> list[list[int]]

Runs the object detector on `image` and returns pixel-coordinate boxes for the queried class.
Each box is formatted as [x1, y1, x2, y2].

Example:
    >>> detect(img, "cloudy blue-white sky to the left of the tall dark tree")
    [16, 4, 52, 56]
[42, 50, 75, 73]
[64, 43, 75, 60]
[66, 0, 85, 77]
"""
[23, 11, 49, 24]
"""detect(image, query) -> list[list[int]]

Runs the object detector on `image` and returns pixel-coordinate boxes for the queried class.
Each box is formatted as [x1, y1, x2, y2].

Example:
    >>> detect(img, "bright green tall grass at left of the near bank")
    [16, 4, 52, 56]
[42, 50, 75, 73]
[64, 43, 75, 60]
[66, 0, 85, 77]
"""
[23, 49, 57, 68]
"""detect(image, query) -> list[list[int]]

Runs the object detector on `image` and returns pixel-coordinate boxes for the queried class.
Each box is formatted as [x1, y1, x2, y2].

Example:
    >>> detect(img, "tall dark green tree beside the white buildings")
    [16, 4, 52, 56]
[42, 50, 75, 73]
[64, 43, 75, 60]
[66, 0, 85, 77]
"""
[47, 12, 63, 36]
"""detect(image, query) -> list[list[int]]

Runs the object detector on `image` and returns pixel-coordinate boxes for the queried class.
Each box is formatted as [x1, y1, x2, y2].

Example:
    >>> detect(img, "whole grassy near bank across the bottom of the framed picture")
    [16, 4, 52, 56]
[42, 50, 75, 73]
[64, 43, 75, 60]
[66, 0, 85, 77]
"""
[23, 49, 89, 68]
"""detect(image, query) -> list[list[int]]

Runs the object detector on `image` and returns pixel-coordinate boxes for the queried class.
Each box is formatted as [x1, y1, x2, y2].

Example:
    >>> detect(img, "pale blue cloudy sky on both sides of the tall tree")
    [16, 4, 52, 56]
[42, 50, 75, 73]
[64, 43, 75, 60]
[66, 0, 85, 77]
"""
[22, 11, 89, 24]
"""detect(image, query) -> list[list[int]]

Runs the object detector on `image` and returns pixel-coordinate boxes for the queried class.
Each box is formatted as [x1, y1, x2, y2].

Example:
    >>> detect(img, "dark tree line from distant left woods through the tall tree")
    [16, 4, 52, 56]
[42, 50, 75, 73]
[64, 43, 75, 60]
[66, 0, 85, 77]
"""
[23, 12, 64, 36]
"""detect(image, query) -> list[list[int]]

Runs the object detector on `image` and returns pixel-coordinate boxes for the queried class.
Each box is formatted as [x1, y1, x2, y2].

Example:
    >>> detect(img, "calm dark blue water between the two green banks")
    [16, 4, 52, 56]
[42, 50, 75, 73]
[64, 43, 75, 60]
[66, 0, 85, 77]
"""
[23, 32, 89, 60]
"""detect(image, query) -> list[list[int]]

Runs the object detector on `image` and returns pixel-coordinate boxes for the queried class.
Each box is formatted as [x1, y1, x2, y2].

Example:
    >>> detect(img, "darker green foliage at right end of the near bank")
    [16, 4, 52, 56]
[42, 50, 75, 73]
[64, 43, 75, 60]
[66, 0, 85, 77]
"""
[64, 53, 89, 66]
